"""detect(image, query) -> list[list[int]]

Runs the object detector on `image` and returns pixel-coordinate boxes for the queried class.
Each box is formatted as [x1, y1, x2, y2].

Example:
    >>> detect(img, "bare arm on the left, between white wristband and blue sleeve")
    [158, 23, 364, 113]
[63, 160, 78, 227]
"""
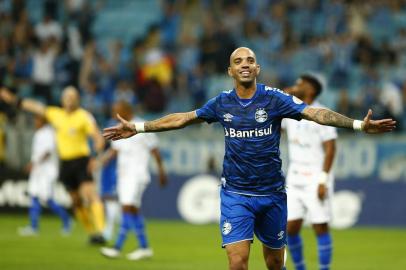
[144, 111, 203, 132]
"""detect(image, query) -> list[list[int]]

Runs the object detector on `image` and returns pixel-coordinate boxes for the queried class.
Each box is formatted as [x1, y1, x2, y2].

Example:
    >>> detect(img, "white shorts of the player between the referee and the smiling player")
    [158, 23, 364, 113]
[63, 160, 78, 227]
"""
[117, 175, 149, 208]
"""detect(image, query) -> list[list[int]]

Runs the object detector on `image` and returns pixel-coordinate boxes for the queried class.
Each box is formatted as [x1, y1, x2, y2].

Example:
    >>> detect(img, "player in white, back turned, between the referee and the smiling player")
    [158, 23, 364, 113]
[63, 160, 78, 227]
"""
[100, 101, 166, 260]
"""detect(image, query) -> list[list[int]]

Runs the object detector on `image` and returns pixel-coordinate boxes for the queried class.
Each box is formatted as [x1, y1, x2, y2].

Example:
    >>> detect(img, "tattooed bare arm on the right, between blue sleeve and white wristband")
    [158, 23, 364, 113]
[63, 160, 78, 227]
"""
[302, 107, 354, 129]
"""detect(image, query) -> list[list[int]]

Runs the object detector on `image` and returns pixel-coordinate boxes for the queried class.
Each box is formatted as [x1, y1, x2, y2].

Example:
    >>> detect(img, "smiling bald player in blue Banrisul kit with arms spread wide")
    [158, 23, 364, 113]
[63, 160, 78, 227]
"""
[103, 47, 396, 270]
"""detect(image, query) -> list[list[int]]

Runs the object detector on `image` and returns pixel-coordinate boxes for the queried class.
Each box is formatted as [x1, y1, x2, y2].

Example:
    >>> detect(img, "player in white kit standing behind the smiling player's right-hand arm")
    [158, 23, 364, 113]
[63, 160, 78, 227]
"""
[282, 75, 337, 270]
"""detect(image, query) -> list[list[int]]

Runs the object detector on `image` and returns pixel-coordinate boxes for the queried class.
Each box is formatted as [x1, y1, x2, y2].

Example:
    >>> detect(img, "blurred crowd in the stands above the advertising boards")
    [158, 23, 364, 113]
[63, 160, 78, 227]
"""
[0, 0, 406, 130]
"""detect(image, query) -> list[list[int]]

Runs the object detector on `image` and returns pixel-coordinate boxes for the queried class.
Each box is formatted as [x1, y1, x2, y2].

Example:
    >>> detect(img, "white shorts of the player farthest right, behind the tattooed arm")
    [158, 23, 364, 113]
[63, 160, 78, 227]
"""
[286, 169, 334, 224]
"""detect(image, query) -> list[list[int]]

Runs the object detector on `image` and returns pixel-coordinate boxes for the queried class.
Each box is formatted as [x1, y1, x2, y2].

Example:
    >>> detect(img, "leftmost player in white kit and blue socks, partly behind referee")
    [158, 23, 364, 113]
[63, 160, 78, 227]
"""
[19, 116, 70, 236]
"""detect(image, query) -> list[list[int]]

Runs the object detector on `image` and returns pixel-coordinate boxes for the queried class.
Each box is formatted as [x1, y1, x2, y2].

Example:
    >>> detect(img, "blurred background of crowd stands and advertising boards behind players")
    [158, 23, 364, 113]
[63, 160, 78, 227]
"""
[0, 0, 406, 268]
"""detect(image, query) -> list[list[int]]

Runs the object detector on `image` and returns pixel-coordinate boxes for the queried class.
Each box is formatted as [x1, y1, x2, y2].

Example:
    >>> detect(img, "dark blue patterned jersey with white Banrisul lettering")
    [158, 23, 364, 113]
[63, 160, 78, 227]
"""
[196, 84, 306, 195]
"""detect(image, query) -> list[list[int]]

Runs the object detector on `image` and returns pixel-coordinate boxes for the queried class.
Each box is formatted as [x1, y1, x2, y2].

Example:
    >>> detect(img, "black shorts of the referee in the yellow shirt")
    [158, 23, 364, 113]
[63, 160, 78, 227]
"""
[59, 157, 93, 191]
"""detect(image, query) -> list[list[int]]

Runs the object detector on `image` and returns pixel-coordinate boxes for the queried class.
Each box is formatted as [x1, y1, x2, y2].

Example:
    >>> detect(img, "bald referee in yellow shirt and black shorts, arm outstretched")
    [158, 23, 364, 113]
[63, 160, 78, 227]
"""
[0, 86, 105, 244]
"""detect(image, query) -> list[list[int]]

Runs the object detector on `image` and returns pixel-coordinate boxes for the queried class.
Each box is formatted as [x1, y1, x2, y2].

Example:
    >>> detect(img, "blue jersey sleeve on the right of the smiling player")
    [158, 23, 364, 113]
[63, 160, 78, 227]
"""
[274, 89, 307, 120]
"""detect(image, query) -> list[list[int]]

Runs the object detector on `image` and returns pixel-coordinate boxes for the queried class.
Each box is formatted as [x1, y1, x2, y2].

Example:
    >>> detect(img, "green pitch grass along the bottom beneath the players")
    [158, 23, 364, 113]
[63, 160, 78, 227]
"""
[0, 214, 406, 270]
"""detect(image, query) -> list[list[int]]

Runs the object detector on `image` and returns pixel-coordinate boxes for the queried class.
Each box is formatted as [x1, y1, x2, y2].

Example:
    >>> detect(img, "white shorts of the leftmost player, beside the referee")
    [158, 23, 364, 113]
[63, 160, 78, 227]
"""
[28, 168, 57, 202]
